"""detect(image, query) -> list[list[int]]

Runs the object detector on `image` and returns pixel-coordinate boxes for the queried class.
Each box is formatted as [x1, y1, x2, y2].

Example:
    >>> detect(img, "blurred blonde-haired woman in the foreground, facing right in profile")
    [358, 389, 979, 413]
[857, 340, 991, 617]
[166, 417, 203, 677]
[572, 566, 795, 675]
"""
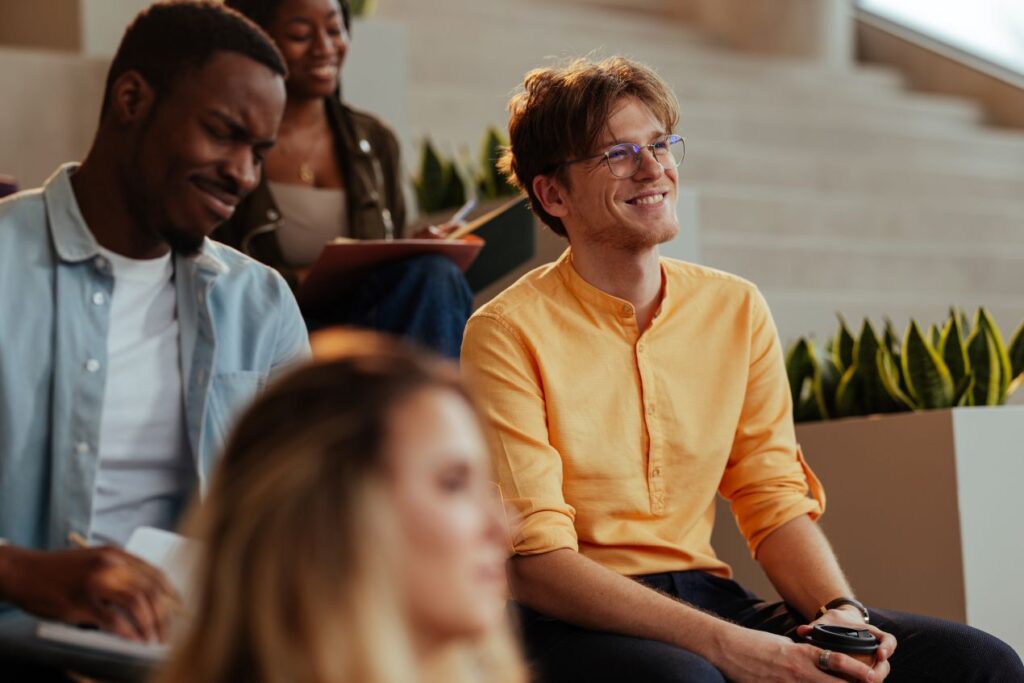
[159, 331, 525, 683]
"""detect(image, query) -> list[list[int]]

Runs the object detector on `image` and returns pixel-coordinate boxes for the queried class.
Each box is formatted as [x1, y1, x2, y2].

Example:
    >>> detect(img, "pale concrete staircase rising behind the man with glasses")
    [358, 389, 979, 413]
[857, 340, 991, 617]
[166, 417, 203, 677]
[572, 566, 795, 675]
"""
[376, 0, 1024, 348]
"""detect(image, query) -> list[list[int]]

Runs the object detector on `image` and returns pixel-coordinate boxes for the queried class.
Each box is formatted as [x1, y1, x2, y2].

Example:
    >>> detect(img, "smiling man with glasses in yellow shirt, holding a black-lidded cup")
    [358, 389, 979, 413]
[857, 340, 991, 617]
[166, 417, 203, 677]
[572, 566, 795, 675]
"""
[463, 58, 1024, 683]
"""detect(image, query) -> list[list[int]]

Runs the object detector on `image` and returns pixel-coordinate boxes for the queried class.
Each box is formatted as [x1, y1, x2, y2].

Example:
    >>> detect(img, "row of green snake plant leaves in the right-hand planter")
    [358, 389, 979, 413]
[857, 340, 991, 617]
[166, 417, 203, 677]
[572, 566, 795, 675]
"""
[786, 308, 1024, 422]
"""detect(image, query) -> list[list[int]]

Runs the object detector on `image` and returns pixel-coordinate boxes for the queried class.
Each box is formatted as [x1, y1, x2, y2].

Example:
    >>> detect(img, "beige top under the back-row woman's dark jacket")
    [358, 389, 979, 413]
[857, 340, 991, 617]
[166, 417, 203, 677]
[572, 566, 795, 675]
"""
[269, 182, 348, 268]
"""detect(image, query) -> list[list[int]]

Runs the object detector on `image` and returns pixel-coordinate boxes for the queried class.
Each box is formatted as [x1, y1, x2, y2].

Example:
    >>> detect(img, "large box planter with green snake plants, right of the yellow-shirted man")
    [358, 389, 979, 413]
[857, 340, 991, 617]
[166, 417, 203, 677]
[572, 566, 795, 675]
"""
[715, 308, 1024, 652]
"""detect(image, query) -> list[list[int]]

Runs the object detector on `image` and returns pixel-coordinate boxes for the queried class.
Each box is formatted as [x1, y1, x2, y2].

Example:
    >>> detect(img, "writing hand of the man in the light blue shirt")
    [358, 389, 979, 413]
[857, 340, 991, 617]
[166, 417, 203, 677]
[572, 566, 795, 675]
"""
[0, 546, 179, 642]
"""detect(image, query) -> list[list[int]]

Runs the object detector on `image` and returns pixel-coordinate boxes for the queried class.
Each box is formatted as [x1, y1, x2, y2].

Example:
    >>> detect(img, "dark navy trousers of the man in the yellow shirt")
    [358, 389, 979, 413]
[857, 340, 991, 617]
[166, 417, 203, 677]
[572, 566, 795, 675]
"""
[519, 571, 1024, 683]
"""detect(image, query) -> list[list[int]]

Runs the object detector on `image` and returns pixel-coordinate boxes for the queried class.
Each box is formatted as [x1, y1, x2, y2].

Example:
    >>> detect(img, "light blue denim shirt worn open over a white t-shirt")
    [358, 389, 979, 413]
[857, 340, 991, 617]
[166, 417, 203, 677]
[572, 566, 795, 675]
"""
[0, 164, 309, 549]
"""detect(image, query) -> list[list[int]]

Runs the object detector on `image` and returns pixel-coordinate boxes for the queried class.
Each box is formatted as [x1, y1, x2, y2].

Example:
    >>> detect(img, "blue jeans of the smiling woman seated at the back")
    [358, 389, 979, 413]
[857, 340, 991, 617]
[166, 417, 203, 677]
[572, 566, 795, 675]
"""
[306, 254, 473, 358]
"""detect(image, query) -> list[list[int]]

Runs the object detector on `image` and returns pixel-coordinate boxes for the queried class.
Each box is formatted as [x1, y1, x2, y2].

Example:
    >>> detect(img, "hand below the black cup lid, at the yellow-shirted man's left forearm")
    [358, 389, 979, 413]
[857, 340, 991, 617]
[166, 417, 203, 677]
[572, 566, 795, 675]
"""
[713, 620, 888, 683]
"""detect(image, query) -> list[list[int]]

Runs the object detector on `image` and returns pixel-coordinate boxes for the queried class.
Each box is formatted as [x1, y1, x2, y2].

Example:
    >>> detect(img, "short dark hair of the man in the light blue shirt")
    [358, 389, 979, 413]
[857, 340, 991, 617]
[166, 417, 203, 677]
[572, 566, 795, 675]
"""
[102, 0, 288, 114]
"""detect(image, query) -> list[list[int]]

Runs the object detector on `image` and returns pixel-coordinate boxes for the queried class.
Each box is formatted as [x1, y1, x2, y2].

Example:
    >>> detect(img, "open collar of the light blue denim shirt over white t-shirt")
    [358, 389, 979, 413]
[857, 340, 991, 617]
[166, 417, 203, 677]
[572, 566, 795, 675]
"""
[43, 163, 230, 275]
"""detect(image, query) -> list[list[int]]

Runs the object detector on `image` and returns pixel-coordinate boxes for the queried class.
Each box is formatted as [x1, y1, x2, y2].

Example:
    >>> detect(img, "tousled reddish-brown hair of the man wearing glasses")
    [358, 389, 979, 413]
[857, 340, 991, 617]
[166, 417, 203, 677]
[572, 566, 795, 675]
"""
[498, 57, 679, 238]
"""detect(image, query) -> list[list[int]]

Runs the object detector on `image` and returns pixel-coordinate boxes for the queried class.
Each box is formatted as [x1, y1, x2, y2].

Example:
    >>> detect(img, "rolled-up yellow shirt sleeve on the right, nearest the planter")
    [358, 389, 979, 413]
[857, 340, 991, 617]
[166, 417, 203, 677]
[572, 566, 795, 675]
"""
[719, 290, 825, 557]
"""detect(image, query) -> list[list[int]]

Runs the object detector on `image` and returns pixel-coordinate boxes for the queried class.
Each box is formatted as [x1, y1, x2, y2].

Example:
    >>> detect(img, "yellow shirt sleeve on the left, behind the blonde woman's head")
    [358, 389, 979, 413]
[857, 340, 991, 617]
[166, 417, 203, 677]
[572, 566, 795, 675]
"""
[462, 315, 579, 555]
